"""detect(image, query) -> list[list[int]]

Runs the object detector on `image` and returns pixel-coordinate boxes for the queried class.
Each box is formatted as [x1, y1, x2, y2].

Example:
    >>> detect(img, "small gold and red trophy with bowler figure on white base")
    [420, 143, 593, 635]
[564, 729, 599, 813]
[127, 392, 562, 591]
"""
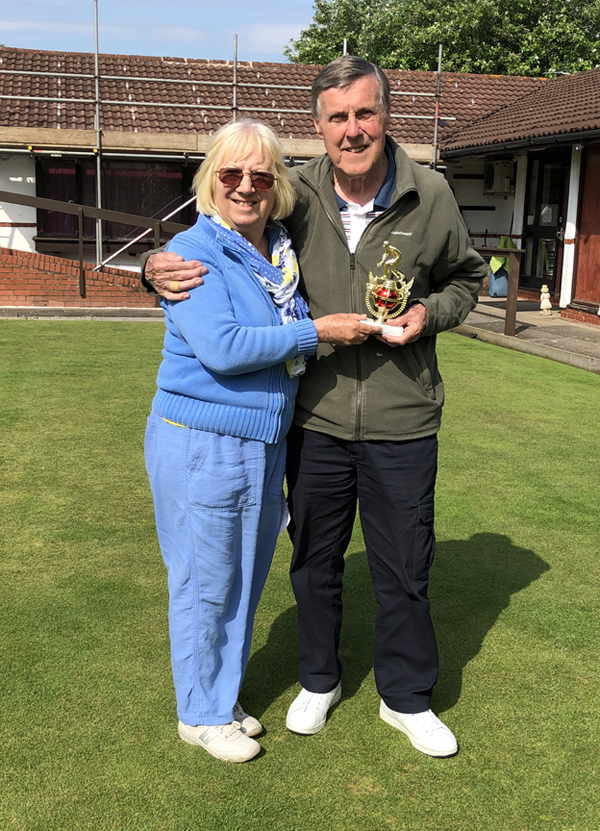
[365, 240, 415, 337]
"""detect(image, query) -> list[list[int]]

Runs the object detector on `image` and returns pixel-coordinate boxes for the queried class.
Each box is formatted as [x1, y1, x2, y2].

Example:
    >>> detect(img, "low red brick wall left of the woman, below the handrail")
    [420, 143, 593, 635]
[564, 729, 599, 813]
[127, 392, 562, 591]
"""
[0, 248, 155, 308]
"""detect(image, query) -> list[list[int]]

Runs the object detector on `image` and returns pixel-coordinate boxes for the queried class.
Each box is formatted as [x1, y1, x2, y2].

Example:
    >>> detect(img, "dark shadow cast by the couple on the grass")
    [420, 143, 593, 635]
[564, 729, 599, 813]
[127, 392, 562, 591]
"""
[244, 533, 549, 716]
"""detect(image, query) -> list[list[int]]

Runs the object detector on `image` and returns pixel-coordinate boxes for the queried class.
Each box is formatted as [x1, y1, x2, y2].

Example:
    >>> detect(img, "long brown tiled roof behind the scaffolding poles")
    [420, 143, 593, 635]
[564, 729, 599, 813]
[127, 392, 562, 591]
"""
[0, 47, 548, 149]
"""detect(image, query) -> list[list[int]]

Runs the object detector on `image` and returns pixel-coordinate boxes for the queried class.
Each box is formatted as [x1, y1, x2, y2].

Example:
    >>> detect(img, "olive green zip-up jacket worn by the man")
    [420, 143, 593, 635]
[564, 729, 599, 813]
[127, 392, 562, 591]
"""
[285, 138, 486, 440]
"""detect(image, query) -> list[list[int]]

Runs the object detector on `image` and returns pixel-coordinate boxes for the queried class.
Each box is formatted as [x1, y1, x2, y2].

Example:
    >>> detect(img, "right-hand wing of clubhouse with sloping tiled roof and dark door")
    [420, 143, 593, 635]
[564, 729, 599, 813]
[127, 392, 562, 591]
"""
[442, 69, 600, 322]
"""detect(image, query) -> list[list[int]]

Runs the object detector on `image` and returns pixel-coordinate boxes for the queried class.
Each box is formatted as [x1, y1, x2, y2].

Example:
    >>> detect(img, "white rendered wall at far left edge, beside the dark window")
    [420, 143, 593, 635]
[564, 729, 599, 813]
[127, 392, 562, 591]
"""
[0, 152, 37, 251]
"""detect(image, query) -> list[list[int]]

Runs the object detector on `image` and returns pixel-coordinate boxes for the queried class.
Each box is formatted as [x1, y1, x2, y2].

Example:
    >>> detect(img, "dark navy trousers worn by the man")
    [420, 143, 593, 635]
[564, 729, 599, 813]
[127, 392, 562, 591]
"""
[286, 427, 439, 713]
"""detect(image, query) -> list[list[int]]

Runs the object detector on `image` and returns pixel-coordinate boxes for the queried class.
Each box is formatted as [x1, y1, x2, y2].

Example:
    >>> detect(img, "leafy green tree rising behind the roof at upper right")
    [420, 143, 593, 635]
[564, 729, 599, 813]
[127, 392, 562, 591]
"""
[285, 0, 600, 76]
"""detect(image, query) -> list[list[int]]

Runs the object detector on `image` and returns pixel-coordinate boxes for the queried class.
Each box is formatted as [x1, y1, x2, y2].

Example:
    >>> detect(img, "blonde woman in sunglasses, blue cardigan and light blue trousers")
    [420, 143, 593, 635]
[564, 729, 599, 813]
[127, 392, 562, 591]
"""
[145, 121, 372, 762]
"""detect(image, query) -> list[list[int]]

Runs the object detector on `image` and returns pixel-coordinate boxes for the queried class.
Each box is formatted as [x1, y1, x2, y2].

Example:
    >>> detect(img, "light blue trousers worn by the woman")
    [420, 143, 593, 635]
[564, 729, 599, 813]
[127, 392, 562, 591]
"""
[144, 412, 287, 725]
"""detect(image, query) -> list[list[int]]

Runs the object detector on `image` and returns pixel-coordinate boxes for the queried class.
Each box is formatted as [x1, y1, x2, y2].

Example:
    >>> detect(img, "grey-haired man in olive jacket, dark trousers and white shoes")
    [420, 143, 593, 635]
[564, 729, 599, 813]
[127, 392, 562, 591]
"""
[146, 56, 485, 757]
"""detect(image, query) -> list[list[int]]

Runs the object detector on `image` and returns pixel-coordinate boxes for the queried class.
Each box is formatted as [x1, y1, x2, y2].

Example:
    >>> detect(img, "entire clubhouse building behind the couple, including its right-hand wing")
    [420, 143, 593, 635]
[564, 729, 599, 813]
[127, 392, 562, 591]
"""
[0, 47, 600, 319]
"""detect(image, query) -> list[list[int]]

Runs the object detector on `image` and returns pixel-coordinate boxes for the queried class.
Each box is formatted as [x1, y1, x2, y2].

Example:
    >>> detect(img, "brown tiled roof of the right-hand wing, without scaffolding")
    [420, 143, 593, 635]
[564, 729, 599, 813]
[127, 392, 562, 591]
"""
[443, 69, 600, 152]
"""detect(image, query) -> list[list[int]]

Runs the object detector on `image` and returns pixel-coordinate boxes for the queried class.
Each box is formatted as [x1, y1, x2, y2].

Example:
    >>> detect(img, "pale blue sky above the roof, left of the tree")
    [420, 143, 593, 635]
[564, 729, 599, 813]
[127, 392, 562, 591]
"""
[0, 0, 313, 62]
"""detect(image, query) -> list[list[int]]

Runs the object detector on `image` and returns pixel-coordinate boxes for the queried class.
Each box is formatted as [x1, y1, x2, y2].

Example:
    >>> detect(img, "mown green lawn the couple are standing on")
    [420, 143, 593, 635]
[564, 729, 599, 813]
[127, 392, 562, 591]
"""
[0, 321, 600, 831]
